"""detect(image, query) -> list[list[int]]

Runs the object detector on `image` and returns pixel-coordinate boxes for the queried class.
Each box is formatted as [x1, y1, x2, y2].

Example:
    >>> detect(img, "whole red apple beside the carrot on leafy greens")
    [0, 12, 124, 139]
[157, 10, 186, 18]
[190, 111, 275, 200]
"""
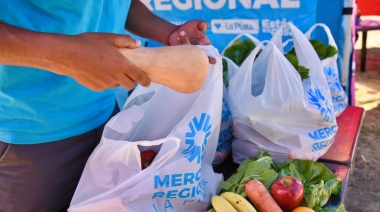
[270, 176, 304, 211]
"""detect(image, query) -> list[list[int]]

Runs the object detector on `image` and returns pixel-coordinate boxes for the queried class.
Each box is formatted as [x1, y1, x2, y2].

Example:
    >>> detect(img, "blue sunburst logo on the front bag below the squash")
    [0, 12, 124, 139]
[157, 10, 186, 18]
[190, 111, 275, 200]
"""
[182, 113, 211, 164]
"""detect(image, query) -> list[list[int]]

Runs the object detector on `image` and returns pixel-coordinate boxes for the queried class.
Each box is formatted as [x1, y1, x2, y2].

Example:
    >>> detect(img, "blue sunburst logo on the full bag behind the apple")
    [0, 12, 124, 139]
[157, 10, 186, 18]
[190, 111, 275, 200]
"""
[307, 88, 334, 121]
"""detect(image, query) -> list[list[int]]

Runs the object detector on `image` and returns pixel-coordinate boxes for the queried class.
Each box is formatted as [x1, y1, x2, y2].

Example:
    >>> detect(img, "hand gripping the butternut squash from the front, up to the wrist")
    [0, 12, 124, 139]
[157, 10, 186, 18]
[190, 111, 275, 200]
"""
[52, 33, 150, 91]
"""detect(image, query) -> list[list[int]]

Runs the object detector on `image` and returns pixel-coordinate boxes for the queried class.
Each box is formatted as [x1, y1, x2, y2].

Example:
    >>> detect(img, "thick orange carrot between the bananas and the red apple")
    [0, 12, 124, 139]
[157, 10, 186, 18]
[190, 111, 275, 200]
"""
[245, 179, 282, 212]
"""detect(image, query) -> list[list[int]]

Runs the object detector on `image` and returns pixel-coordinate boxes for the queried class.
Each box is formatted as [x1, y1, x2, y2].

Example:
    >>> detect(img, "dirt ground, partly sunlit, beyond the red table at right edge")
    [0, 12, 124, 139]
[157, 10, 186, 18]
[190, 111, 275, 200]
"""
[345, 16, 380, 212]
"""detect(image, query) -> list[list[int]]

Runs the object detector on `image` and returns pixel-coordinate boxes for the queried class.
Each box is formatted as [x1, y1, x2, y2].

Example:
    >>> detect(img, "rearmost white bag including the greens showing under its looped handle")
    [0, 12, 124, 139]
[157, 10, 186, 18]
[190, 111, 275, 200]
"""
[305, 23, 348, 117]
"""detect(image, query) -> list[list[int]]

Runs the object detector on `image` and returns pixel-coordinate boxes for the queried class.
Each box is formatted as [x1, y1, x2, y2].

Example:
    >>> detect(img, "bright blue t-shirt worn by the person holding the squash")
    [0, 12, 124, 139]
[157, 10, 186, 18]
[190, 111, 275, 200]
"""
[0, 0, 130, 144]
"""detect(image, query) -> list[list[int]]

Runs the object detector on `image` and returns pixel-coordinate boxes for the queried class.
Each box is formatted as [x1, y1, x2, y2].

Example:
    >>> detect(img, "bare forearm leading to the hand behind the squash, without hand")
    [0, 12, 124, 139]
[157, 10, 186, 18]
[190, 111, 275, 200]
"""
[125, 0, 176, 44]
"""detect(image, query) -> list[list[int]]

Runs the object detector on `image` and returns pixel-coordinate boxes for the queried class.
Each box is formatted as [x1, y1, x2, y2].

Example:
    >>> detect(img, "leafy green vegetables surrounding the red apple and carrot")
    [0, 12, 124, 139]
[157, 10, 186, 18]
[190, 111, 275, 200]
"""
[220, 151, 346, 212]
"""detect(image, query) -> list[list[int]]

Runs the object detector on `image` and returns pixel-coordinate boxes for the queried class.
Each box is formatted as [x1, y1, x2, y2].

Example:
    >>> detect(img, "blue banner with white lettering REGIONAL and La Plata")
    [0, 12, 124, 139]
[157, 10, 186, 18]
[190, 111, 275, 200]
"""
[141, 0, 317, 51]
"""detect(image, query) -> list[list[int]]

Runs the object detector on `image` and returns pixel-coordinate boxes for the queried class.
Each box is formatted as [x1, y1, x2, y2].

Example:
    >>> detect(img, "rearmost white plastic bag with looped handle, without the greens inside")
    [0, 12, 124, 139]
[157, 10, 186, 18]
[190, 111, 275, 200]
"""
[305, 23, 348, 117]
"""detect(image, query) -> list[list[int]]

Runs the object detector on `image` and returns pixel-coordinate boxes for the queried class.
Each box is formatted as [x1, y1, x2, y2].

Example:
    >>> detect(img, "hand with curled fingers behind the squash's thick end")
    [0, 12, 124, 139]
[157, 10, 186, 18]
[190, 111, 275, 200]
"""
[167, 20, 216, 64]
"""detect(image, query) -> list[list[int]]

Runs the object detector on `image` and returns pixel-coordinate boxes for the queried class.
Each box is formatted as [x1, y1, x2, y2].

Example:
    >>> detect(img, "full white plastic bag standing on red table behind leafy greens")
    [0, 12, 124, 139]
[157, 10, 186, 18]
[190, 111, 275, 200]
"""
[228, 41, 337, 163]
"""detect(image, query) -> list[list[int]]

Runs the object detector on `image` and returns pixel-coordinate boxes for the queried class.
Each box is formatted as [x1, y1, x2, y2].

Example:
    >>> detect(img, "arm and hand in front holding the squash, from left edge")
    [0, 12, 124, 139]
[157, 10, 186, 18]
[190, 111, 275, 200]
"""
[0, 21, 150, 91]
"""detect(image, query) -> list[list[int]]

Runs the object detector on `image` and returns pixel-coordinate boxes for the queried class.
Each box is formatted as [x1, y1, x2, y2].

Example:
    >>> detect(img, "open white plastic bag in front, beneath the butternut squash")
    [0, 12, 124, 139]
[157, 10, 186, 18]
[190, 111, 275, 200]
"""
[69, 46, 223, 212]
